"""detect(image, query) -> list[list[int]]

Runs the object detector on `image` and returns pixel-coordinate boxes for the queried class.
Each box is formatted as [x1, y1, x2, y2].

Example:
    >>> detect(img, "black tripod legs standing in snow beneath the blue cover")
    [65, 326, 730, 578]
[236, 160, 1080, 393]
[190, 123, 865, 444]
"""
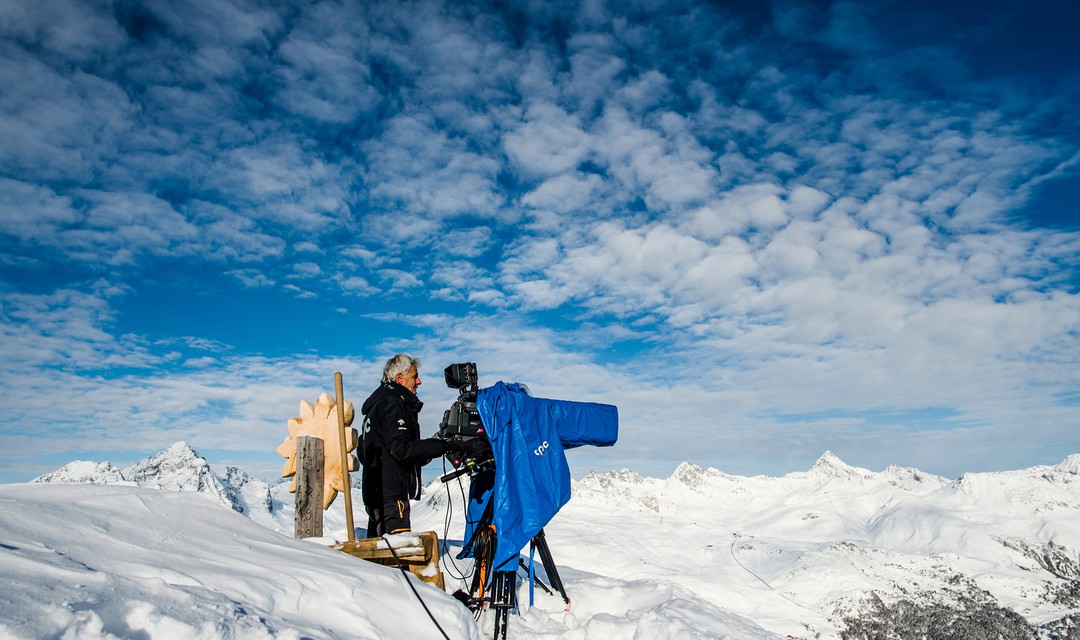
[465, 522, 570, 640]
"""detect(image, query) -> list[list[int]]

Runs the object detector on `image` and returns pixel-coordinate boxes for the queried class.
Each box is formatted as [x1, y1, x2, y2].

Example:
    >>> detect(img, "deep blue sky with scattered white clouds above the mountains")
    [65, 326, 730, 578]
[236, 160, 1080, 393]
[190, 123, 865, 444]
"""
[0, 0, 1080, 481]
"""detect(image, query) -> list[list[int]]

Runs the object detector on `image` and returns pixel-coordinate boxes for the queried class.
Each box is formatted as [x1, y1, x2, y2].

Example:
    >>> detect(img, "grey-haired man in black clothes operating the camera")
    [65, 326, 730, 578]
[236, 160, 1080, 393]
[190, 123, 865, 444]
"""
[361, 353, 477, 537]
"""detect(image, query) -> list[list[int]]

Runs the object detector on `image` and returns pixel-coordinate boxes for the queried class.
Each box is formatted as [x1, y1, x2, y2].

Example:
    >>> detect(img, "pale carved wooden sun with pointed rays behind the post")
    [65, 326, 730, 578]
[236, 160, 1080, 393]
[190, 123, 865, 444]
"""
[278, 393, 360, 509]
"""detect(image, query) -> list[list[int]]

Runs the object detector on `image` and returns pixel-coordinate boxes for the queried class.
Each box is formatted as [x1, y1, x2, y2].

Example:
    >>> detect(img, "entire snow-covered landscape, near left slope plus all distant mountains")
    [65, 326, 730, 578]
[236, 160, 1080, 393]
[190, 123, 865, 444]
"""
[6, 442, 1080, 639]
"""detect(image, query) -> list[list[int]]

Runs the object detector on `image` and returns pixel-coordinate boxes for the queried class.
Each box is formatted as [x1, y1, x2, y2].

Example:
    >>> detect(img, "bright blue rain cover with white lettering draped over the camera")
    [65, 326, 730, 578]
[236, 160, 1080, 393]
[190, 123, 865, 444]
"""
[464, 381, 619, 571]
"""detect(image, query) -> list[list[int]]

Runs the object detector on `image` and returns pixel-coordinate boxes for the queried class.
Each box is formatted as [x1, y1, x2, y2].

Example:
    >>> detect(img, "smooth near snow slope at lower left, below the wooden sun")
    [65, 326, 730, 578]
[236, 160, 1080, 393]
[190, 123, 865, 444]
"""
[0, 484, 481, 640]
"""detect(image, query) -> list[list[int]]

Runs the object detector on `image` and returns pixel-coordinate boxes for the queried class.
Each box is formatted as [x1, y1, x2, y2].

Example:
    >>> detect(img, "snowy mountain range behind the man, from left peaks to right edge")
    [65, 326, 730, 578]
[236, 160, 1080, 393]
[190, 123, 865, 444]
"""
[21, 444, 1080, 640]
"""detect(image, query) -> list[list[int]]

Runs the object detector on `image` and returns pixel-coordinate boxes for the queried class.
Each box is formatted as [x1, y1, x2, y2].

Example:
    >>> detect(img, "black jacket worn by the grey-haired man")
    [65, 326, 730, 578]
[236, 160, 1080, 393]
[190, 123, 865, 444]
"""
[361, 382, 446, 506]
